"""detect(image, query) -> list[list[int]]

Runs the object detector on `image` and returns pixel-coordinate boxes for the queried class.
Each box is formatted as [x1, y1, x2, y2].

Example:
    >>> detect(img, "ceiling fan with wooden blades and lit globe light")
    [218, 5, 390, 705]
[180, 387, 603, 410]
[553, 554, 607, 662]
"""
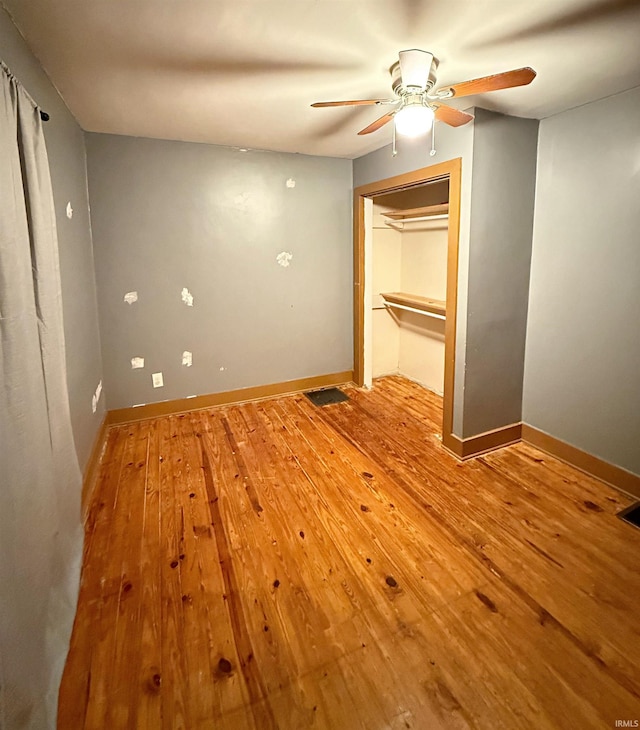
[311, 49, 536, 137]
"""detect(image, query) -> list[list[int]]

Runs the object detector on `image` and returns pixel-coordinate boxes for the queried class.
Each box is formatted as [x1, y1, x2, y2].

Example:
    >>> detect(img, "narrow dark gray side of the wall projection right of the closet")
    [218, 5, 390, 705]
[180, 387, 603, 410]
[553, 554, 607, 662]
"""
[463, 109, 538, 437]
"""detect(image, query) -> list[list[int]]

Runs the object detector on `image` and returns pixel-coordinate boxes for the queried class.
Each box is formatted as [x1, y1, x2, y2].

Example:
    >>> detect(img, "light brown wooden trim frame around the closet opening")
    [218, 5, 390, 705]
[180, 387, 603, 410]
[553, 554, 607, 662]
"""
[353, 157, 462, 451]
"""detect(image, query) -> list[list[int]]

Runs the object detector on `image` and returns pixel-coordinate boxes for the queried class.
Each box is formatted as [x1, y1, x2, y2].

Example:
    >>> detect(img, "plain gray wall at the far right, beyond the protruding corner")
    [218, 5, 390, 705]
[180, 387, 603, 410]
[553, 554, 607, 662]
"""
[523, 88, 640, 474]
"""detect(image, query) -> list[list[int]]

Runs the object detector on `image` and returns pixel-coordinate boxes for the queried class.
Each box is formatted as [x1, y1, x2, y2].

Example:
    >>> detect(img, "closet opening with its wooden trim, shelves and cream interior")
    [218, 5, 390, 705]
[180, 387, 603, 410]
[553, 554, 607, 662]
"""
[354, 158, 461, 450]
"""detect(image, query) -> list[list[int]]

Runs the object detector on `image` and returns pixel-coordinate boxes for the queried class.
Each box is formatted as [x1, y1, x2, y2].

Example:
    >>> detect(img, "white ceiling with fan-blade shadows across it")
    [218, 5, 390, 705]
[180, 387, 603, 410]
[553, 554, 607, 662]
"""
[1, 0, 640, 157]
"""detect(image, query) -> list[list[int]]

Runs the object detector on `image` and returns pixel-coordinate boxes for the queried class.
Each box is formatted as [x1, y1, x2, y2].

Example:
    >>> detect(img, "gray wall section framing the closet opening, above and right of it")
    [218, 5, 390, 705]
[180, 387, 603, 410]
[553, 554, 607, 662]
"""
[353, 109, 474, 436]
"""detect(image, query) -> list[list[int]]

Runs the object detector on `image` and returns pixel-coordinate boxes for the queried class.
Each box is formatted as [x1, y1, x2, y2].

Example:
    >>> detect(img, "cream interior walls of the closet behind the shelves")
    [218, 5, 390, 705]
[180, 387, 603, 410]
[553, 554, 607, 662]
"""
[371, 180, 448, 395]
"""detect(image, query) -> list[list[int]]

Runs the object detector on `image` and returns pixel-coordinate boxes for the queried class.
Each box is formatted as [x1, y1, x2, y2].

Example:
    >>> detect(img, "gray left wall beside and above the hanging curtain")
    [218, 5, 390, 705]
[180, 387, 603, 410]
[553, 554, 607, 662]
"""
[0, 8, 105, 468]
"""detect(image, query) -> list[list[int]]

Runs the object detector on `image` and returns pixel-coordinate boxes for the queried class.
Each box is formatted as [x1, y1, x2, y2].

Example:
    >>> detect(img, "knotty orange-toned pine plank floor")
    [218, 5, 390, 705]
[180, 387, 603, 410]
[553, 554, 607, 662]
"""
[59, 378, 640, 730]
